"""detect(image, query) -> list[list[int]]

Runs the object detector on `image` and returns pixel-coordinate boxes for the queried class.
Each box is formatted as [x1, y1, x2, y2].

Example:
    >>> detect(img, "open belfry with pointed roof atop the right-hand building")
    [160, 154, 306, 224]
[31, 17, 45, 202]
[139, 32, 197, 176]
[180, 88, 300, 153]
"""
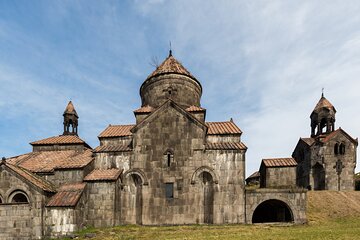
[310, 93, 336, 137]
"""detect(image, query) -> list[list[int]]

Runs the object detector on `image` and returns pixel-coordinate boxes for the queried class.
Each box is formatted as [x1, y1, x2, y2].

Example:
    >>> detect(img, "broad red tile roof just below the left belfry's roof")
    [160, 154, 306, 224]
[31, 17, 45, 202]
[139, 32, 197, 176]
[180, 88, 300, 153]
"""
[7, 149, 93, 173]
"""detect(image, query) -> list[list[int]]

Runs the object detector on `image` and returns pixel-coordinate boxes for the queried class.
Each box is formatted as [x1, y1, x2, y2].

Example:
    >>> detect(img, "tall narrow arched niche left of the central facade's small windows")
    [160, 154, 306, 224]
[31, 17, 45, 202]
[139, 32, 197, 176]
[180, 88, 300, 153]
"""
[129, 174, 143, 225]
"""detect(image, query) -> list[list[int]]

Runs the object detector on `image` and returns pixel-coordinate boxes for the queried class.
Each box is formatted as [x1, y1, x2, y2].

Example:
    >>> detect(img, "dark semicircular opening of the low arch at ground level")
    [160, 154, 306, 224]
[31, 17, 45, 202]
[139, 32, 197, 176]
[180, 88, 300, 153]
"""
[252, 199, 294, 223]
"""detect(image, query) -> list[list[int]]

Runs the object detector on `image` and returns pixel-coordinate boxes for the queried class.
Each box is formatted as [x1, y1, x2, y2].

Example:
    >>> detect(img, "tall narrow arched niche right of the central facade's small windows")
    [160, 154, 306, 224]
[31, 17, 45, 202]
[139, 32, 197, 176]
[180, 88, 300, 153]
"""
[199, 171, 214, 224]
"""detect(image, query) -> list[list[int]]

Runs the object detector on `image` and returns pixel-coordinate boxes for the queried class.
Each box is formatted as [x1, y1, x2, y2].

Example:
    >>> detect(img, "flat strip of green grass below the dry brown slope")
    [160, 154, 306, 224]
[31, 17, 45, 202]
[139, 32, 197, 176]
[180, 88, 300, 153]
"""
[62, 218, 360, 240]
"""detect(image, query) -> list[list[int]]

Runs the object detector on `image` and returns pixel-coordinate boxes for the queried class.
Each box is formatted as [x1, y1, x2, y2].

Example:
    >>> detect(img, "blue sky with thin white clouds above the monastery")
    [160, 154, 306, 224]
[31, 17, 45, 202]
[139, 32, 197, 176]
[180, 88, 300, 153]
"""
[0, 0, 360, 175]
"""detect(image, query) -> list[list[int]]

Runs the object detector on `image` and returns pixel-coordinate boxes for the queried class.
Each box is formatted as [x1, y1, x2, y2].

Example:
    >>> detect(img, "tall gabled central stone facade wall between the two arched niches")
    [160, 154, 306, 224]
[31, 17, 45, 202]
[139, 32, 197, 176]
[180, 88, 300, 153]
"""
[129, 106, 205, 225]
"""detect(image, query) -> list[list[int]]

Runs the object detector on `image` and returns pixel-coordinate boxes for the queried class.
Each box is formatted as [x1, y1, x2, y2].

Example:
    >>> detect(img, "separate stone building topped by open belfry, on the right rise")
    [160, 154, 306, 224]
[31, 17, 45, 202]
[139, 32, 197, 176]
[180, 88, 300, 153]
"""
[292, 94, 358, 191]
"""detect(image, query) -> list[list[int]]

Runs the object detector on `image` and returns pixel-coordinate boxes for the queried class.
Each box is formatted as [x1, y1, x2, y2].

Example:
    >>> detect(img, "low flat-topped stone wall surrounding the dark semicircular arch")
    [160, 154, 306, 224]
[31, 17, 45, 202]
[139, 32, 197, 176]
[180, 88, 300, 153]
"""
[246, 188, 307, 224]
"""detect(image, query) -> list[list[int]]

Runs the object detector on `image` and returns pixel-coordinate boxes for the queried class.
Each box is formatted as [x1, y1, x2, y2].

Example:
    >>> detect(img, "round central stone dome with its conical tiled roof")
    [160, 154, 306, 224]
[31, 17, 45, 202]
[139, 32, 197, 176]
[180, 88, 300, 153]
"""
[140, 51, 202, 108]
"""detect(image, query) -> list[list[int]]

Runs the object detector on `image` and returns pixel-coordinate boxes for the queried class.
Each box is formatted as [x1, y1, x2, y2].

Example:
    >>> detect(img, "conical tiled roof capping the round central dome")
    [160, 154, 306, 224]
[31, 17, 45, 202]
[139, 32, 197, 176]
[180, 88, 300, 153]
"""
[146, 55, 195, 79]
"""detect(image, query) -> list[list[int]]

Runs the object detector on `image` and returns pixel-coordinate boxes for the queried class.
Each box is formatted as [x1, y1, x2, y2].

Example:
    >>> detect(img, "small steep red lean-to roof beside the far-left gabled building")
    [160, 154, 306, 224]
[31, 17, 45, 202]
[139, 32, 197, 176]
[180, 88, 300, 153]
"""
[46, 183, 86, 207]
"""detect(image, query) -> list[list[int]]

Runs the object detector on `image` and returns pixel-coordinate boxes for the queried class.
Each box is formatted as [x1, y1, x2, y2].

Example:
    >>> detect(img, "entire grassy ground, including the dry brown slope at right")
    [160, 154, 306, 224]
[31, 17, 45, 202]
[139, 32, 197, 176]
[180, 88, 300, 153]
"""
[63, 191, 360, 240]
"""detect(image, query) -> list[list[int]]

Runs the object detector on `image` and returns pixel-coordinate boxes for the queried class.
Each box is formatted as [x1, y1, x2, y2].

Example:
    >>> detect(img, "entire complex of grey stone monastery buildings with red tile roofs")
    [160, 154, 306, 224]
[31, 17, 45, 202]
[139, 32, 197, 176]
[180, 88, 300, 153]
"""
[0, 51, 358, 239]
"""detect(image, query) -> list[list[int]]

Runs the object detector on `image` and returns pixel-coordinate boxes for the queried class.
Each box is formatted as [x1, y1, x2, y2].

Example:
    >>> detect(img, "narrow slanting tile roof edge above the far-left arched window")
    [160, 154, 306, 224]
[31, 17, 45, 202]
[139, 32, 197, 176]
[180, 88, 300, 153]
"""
[6, 163, 56, 192]
